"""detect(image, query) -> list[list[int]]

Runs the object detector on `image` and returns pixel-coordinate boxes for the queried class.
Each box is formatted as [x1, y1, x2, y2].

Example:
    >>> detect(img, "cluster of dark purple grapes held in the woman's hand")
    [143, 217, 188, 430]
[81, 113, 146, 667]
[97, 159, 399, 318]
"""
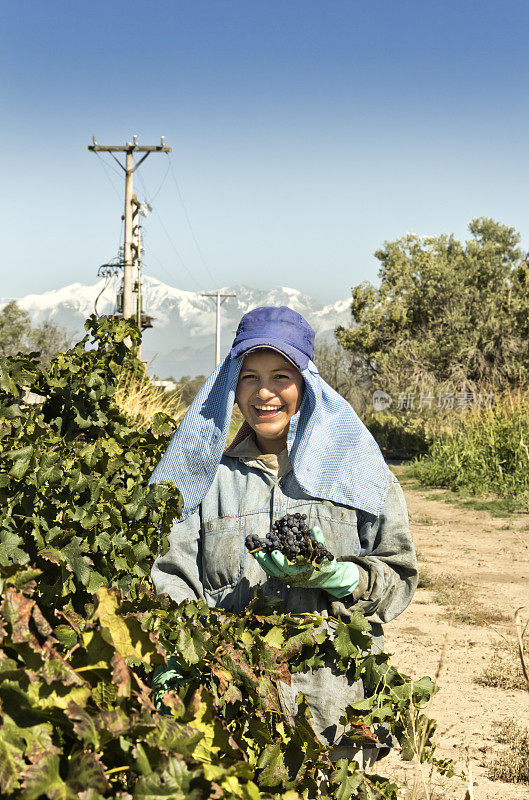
[245, 514, 334, 564]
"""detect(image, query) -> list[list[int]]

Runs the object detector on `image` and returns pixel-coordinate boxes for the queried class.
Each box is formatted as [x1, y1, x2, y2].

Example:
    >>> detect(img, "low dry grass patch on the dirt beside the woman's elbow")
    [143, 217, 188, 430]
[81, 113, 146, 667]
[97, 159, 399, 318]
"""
[419, 567, 508, 626]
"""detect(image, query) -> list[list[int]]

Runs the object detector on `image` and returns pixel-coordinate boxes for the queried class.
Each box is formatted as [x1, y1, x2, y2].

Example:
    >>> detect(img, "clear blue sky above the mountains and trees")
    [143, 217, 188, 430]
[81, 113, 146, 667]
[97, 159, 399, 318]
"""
[0, 0, 529, 302]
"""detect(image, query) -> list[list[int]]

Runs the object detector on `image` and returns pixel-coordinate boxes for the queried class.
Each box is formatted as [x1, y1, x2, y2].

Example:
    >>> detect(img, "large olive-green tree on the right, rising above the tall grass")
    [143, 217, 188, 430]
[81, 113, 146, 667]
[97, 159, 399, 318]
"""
[336, 217, 529, 392]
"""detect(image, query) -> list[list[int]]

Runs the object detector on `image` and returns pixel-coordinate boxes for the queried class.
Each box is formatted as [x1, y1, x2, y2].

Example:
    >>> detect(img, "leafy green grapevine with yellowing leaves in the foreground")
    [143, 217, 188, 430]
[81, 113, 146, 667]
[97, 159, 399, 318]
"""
[0, 317, 449, 800]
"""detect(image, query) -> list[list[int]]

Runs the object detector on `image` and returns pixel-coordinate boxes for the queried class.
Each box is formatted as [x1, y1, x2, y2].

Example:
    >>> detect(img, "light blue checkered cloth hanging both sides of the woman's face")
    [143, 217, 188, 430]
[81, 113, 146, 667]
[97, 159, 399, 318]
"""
[149, 356, 390, 519]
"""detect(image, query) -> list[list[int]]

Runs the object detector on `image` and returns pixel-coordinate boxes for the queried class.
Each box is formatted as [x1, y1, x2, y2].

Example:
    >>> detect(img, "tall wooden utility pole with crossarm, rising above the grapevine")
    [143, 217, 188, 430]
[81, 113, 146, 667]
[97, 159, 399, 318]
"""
[88, 136, 171, 328]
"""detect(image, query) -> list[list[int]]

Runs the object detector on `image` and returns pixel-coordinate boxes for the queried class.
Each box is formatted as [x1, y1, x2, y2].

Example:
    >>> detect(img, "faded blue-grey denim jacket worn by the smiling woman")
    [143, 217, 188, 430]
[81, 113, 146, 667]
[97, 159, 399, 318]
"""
[152, 440, 418, 744]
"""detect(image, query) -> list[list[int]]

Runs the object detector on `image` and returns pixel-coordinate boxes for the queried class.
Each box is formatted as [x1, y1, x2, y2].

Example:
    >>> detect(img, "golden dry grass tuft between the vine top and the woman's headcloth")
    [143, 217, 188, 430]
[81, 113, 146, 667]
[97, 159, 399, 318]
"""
[114, 371, 186, 430]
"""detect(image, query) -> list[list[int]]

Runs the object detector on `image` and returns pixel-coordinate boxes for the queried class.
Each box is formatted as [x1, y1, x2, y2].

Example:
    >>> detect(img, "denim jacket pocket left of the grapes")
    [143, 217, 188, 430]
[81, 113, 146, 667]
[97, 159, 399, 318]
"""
[202, 517, 245, 593]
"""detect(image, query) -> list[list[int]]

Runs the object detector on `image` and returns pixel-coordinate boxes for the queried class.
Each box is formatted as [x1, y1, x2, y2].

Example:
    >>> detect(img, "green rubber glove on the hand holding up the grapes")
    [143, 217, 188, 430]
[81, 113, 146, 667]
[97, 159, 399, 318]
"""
[254, 528, 359, 600]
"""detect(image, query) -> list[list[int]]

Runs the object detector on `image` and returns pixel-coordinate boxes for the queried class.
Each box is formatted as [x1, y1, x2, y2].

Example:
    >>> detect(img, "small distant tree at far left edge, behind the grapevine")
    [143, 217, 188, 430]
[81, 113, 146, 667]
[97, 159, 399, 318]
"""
[0, 300, 72, 367]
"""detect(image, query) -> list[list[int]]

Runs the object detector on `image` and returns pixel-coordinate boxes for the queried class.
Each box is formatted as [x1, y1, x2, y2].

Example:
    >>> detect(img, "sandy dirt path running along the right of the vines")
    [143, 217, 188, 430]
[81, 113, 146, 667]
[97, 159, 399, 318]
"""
[380, 467, 529, 800]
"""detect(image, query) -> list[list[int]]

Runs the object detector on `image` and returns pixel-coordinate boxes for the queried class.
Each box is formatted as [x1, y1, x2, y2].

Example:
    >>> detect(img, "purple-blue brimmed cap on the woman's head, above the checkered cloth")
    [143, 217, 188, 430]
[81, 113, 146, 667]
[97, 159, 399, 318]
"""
[230, 306, 315, 371]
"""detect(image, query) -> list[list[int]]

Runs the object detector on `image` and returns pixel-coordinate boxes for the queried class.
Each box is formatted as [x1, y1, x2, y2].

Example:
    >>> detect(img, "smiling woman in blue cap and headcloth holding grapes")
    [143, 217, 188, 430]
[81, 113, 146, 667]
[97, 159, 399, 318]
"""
[148, 306, 417, 765]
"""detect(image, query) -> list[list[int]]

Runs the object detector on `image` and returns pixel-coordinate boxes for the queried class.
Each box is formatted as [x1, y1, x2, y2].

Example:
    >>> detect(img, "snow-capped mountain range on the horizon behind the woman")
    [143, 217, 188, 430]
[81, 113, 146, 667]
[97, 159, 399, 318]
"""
[4, 276, 351, 378]
